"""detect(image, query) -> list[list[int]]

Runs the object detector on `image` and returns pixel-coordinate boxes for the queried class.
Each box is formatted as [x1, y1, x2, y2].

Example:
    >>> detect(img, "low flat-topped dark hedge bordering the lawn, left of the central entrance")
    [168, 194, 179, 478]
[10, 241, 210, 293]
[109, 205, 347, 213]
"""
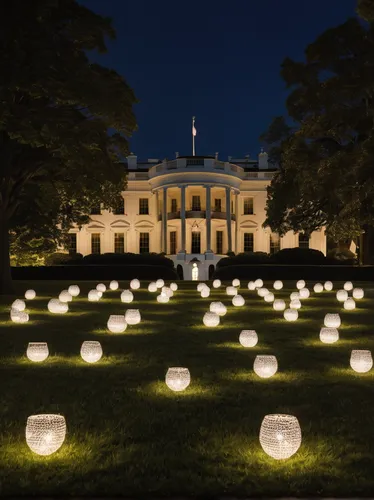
[12, 264, 178, 281]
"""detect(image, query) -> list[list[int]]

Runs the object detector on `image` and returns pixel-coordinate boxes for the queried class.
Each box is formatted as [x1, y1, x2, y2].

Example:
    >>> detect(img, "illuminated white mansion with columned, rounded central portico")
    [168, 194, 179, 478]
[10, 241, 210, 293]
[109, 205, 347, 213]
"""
[69, 152, 326, 279]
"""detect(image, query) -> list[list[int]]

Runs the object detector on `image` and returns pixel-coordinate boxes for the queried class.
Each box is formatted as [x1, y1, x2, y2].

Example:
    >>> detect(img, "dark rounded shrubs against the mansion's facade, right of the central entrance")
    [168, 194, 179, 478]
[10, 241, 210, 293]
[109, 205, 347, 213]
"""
[217, 248, 355, 268]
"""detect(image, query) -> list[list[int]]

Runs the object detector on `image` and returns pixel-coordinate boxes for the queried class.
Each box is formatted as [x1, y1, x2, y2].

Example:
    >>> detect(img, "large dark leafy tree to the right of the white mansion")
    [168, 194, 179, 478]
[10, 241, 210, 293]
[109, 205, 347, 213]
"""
[263, 13, 374, 256]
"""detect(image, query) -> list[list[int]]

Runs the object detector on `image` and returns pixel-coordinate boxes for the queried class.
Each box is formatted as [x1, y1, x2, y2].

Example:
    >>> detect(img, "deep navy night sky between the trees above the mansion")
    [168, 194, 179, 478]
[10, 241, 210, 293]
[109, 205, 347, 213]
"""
[81, 0, 356, 160]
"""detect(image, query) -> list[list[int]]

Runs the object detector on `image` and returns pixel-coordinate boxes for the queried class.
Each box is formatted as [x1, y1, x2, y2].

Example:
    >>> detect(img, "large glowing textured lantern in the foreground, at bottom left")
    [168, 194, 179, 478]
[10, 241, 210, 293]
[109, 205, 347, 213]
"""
[26, 414, 66, 456]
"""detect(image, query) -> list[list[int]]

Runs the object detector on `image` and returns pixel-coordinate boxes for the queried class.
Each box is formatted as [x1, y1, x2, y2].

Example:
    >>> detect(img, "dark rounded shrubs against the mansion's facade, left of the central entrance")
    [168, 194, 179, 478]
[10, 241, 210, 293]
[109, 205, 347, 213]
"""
[45, 253, 174, 268]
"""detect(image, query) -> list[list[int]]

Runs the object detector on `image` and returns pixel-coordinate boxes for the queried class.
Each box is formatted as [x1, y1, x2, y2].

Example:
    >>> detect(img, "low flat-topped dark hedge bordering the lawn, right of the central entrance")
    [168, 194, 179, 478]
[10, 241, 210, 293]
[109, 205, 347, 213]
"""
[213, 264, 374, 282]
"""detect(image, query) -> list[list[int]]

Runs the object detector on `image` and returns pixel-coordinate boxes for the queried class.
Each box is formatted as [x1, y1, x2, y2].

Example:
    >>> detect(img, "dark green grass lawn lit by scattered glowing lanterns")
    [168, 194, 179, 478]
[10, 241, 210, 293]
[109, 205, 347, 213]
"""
[0, 282, 374, 498]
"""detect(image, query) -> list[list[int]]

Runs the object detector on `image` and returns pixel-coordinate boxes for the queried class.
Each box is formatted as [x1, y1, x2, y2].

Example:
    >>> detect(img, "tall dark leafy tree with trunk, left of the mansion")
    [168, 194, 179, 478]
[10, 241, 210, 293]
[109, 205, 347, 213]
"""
[0, 0, 137, 293]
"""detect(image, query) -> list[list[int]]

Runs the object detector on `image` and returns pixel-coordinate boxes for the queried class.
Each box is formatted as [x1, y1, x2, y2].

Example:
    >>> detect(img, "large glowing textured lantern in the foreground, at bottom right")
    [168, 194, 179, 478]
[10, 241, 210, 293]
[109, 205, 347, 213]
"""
[260, 414, 301, 460]
